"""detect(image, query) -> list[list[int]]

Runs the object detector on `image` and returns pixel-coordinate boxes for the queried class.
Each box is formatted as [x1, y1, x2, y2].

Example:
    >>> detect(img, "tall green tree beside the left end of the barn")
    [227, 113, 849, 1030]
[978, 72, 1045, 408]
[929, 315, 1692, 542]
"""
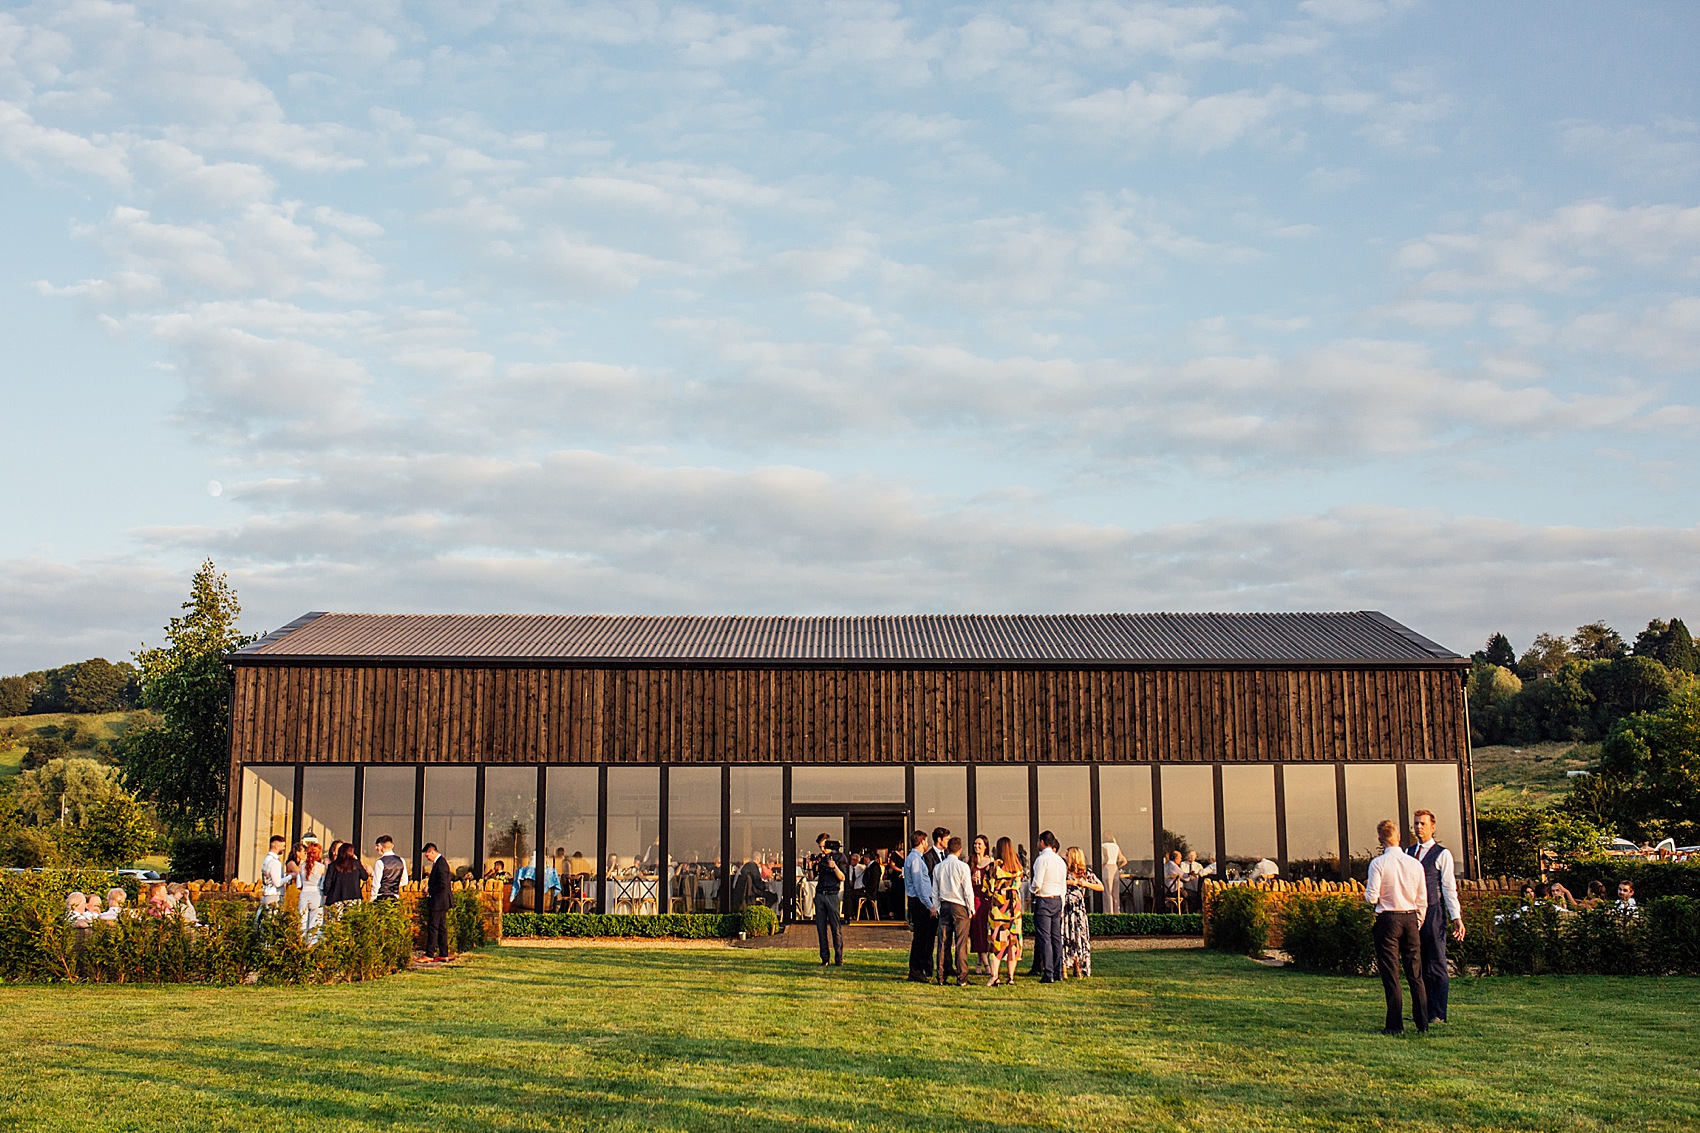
[119, 560, 248, 834]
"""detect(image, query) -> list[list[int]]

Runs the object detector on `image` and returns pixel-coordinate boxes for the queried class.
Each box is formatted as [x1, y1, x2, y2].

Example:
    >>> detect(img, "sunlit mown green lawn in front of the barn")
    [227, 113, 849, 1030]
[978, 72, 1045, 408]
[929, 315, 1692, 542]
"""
[0, 948, 1700, 1133]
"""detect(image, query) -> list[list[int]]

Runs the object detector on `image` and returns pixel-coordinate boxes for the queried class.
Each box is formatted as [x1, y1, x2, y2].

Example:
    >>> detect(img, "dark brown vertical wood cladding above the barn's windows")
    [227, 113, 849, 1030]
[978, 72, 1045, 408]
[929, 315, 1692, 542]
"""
[231, 665, 1467, 764]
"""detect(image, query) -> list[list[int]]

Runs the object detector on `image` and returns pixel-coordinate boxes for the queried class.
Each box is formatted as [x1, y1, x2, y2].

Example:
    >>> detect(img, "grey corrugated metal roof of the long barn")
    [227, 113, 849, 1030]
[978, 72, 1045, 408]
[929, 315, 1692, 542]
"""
[233, 611, 1464, 665]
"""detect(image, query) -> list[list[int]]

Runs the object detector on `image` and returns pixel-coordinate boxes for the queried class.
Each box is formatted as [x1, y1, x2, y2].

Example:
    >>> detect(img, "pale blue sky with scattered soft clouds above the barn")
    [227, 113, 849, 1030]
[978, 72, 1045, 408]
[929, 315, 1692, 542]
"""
[0, 0, 1700, 672]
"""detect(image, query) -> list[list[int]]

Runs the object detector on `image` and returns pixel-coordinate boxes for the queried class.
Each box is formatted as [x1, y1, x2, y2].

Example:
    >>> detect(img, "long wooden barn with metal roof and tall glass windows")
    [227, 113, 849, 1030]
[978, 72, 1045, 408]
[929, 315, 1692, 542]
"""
[226, 611, 1476, 912]
